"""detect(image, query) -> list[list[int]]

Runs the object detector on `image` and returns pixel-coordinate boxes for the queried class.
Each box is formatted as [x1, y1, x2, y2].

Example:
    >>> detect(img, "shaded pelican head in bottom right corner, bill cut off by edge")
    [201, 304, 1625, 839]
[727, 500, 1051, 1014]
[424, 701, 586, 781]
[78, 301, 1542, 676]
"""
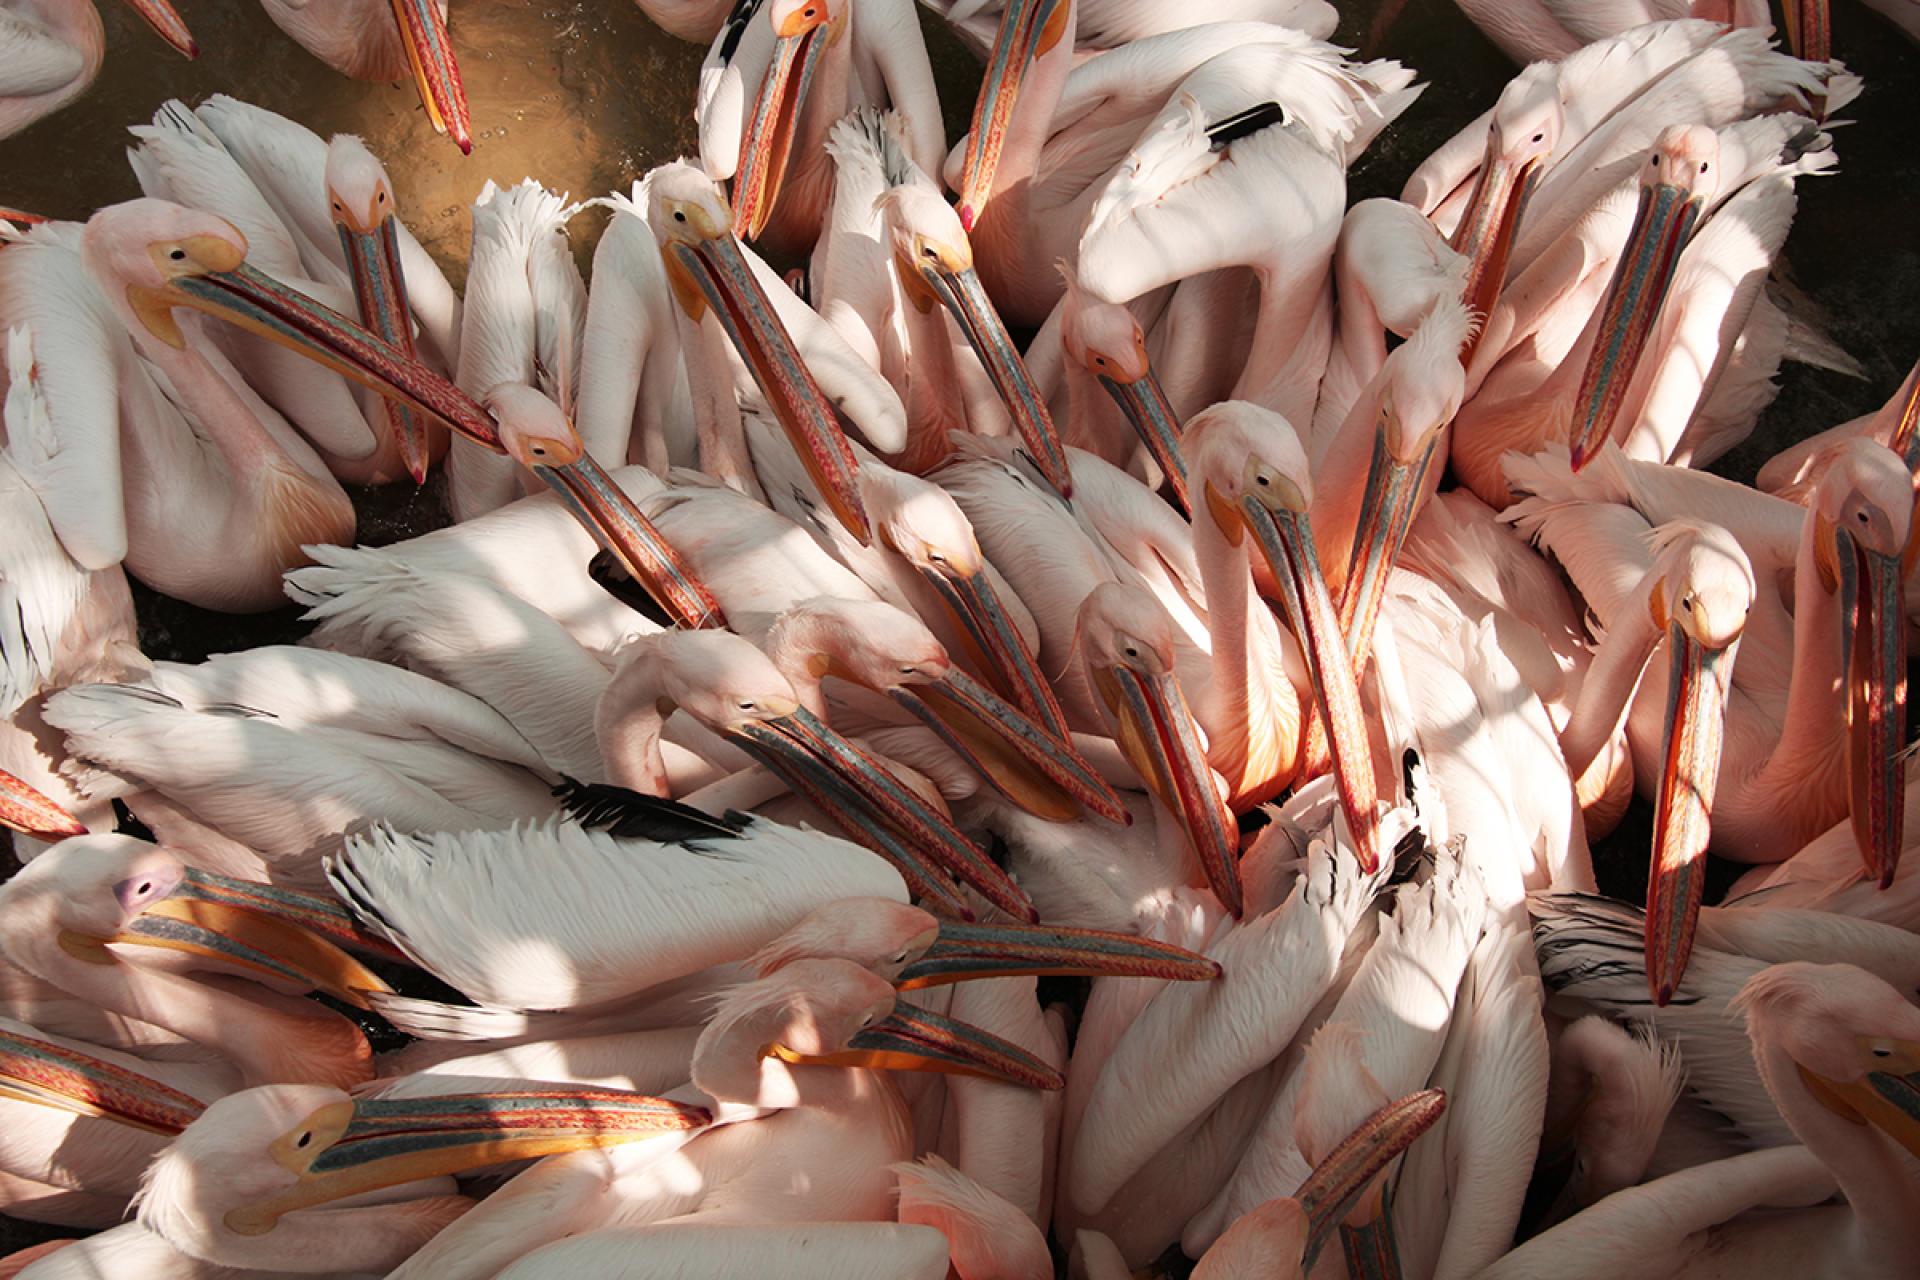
[1730, 961, 1920, 1155]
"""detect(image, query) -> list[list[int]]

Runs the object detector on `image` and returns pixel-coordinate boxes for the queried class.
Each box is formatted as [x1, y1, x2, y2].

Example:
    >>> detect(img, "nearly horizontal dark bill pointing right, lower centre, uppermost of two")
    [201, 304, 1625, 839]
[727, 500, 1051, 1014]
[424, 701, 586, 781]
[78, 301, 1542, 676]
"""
[893, 919, 1221, 990]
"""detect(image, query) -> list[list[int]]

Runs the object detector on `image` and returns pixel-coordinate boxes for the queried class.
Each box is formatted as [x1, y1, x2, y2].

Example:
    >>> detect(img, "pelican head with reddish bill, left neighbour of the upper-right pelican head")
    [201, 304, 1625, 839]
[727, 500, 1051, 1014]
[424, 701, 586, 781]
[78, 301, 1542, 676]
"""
[1453, 63, 1567, 339]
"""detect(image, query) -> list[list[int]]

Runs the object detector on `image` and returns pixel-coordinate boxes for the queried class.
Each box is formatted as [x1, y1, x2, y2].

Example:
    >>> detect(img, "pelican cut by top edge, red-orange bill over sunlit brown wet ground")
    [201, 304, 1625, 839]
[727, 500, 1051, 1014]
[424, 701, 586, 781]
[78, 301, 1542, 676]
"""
[261, 0, 474, 154]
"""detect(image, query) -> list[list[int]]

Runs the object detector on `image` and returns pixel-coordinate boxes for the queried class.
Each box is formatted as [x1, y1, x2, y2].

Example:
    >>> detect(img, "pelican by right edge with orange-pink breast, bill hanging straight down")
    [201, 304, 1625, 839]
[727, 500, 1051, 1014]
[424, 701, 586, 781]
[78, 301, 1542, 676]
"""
[1515, 439, 1912, 901]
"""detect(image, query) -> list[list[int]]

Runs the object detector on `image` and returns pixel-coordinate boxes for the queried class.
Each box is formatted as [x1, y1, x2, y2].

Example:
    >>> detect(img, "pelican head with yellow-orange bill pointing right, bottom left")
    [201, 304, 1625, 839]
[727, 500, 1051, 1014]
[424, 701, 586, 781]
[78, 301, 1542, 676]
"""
[140, 1084, 710, 1270]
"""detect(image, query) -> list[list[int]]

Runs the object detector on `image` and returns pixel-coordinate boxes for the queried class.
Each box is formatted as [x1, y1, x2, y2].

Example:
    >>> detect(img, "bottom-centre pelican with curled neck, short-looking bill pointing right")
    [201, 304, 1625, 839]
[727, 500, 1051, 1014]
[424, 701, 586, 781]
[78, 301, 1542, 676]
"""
[374, 960, 1060, 1280]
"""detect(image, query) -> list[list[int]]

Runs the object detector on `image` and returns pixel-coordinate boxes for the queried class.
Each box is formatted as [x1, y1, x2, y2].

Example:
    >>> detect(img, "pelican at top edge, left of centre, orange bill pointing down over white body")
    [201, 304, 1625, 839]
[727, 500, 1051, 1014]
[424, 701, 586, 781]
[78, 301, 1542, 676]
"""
[695, 0, 947, 255]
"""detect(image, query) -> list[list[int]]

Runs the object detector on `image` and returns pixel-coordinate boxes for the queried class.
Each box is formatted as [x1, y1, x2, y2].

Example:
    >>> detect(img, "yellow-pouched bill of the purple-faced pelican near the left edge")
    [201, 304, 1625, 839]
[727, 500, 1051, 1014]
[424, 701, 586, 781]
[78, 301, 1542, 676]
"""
[60, 873, 394, 1009]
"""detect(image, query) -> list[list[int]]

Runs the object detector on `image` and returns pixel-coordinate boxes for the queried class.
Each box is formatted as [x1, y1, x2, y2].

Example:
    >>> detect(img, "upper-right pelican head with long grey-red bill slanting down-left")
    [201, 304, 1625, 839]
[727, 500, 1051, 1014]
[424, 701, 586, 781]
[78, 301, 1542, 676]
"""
[1569, 125, 1720, 470]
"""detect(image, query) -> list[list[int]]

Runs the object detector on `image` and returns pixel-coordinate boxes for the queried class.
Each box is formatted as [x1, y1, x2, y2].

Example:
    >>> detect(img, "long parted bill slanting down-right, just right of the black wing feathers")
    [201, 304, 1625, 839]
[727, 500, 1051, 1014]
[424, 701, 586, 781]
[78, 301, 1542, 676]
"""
[726, 706, 1039, 921]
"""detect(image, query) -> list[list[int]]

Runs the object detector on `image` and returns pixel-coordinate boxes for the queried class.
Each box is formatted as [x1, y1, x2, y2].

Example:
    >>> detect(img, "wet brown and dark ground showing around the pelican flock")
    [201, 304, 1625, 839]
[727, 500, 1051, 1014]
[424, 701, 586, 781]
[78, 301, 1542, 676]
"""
[0, 0, 1920, 1255]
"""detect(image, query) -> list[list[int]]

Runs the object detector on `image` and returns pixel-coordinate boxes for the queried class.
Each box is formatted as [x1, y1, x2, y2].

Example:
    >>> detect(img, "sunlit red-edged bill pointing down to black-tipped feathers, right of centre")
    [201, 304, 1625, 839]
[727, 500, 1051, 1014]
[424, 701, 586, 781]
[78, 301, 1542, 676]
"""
[1208, 485, 1379, 875]
